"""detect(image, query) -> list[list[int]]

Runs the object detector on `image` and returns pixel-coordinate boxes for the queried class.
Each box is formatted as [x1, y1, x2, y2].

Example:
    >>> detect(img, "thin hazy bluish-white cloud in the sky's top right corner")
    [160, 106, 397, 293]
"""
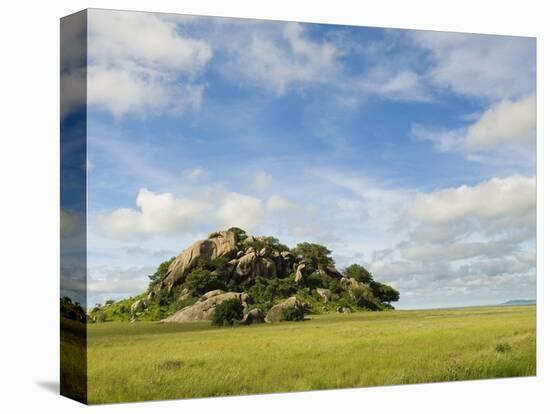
[408, 30, 536, 101]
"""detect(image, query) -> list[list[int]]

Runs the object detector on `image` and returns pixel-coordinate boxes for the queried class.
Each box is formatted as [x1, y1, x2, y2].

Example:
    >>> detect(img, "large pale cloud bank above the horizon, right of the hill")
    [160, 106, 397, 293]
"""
[368, 176, 536, 303]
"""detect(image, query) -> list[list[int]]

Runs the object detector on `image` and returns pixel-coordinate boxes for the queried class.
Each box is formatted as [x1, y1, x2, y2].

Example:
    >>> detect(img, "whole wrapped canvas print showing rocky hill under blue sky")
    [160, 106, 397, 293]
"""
[60, 9, 537, 404]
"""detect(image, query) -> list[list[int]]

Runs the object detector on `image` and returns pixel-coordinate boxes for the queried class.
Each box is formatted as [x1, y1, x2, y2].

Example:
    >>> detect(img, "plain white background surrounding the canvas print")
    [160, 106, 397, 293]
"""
[0, 0, 550, 414]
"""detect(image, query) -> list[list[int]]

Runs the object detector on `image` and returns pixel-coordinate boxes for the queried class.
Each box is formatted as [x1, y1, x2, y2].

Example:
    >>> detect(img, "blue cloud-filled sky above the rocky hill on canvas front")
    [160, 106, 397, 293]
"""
[62, 10, 536, 309]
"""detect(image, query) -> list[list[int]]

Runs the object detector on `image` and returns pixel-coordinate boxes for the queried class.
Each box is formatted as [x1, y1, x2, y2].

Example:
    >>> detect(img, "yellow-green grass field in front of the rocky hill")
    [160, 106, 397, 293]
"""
[88, 306, 536, 403]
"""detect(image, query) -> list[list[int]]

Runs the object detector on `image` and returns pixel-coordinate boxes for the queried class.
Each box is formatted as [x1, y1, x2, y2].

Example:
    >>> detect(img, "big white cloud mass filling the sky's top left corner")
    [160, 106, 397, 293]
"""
[88, 10, 212, 117]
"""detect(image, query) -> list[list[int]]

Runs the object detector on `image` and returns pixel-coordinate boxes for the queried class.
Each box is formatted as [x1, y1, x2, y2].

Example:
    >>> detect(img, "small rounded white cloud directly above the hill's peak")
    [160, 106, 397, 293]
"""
[217, 192, 265, 231]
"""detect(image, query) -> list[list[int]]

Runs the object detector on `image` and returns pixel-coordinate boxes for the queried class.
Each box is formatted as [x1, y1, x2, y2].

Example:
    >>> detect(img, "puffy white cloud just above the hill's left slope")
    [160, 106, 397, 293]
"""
[97, 189, 211, 240]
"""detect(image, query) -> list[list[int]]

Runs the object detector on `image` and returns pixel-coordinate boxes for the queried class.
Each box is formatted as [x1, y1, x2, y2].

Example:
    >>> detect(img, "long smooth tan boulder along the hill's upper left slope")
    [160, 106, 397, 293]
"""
[162, 231, 238, 289]
